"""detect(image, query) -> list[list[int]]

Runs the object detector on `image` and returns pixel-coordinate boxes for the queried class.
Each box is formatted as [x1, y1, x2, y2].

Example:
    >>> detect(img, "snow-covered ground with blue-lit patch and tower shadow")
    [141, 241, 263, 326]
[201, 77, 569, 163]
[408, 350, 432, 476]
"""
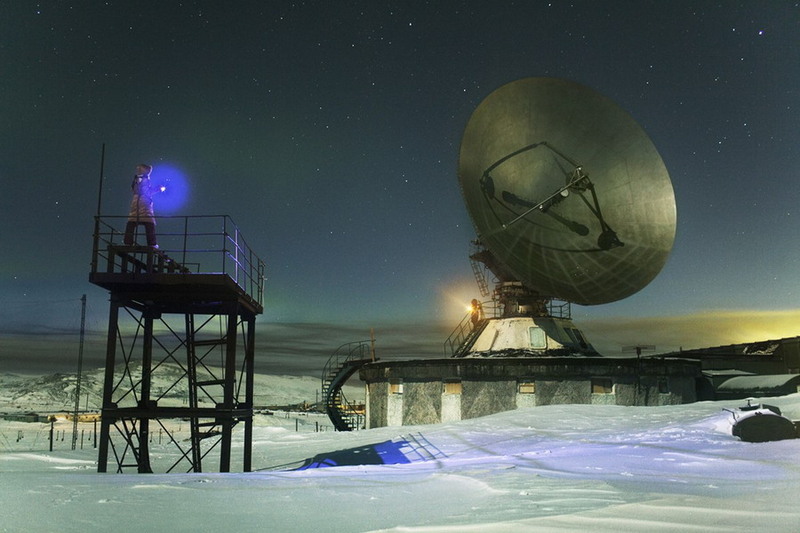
[0, 370, 800, 532]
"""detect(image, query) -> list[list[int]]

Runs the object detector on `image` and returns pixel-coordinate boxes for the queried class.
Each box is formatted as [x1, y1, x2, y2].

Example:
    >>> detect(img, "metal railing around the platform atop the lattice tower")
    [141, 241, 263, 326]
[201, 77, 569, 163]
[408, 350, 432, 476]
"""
[91, 215, 266, 305]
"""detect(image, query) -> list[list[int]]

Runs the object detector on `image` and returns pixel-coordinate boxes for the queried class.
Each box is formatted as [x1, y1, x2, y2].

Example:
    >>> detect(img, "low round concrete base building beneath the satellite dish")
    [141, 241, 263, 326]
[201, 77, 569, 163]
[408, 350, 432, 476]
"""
[359, 356, 701, 428]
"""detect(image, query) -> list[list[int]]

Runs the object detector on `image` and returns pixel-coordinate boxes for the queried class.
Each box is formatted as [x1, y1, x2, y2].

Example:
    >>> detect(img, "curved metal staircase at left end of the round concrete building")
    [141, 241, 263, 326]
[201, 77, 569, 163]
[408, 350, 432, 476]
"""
[322, 341, 375, 431]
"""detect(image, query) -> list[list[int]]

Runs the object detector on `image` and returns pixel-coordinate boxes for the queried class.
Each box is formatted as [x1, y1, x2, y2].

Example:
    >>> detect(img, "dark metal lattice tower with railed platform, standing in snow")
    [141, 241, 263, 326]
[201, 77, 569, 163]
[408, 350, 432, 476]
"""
[89, 215, 264, 473]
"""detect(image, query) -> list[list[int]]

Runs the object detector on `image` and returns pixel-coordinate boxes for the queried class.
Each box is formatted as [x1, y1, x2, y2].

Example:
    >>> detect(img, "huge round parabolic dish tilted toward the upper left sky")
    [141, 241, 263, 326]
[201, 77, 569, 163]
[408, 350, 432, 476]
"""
[459, 78, 676, 305]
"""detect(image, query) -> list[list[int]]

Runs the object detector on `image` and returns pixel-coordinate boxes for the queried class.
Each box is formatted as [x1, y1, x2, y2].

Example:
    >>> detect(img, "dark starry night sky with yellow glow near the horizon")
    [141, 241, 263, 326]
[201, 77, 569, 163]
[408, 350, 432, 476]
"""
[0, 0, 800, 374]
